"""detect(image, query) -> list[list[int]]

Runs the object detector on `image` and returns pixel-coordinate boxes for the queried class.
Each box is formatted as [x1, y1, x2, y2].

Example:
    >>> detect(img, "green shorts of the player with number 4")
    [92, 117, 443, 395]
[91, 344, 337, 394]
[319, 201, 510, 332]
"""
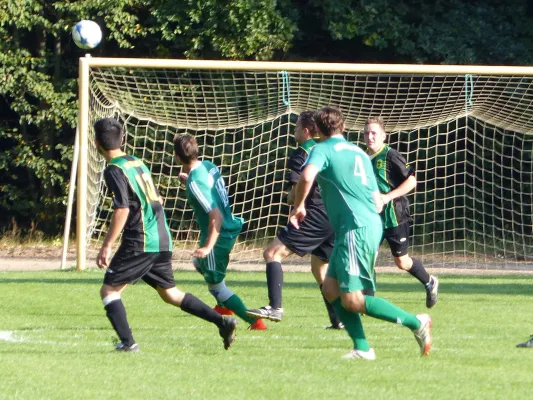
[327, 225, 383, 293]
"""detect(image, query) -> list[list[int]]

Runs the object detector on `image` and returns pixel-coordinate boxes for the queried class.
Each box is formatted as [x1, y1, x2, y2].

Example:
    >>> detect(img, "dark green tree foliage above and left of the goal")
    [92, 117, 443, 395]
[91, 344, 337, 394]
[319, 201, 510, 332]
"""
[0, 0, 533, 235]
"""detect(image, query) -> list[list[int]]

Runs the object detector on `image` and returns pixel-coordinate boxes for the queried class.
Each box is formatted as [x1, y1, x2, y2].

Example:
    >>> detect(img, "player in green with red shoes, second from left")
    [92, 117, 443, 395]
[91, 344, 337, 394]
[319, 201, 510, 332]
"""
[174, 135, 267, 330]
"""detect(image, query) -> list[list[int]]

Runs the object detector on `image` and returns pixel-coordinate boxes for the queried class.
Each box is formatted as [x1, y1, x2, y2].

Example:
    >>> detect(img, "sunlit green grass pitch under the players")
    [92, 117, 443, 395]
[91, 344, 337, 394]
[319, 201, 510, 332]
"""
[0, 271, 533, 400]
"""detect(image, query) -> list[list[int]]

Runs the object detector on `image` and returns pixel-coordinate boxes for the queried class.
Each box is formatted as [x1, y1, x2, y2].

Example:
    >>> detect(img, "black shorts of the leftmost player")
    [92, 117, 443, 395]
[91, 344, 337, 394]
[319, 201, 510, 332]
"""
[104, 245, 176, 289]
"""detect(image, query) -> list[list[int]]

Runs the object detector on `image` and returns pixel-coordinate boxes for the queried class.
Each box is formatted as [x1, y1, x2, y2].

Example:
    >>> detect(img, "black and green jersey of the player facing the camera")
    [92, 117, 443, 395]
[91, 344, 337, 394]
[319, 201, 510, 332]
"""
[370, 145, 415, 229]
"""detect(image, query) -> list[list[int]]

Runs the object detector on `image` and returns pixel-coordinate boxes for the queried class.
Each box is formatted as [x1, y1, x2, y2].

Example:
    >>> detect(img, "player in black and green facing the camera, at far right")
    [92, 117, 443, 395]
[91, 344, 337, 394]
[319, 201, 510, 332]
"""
[364, 117, 439, 308]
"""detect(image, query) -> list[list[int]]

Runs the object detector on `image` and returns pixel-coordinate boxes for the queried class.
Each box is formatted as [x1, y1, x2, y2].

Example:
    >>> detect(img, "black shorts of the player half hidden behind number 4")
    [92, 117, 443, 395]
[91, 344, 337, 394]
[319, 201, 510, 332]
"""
[278, 208, 335, 262]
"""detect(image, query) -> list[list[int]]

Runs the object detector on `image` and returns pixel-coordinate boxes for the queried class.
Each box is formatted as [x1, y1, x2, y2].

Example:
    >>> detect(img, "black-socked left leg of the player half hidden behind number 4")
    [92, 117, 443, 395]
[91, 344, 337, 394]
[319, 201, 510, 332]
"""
[247, 235, 292, 322]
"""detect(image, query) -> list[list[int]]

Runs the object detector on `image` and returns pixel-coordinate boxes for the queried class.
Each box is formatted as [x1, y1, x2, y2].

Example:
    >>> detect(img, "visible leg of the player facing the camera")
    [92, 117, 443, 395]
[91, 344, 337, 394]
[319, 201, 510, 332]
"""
[385, 223, 439, 308]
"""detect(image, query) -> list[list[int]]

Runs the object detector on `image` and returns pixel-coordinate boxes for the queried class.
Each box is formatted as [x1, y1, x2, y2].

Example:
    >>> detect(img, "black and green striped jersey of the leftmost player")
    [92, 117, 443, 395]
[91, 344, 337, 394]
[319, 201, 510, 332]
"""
[104, 155, 172, 253]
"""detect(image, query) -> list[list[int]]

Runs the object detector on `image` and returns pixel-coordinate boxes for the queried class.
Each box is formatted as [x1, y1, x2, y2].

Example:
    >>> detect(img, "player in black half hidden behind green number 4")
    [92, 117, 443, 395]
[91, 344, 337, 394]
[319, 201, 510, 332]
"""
[247, 111, 343, 329]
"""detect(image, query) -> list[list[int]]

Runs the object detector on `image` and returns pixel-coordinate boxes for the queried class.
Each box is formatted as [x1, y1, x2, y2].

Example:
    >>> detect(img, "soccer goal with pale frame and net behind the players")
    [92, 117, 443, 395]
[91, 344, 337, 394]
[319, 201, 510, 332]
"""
[65, 57, 533, 269]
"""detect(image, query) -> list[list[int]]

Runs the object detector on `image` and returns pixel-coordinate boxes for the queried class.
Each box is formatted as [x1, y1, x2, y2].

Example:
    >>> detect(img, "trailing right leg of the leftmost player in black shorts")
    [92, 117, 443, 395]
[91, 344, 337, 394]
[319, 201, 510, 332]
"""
[143, 251, 237, 350]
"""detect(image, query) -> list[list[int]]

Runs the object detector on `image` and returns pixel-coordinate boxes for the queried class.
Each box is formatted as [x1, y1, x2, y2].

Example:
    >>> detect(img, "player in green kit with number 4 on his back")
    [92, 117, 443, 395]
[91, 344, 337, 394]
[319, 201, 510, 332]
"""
[290, 107, 431, 360]
